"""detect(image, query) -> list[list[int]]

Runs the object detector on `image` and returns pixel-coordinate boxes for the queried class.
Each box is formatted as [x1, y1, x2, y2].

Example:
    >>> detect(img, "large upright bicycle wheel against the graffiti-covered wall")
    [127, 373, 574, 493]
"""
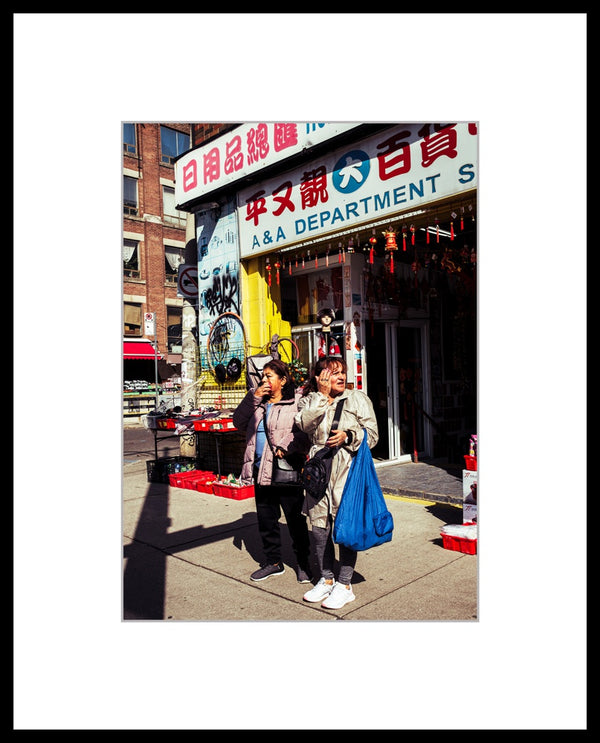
[206, 312, 246, 384]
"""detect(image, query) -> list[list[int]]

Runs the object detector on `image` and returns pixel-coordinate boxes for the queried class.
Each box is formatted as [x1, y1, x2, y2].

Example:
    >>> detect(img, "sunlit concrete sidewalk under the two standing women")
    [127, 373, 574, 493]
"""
[122, 459, 478, 621]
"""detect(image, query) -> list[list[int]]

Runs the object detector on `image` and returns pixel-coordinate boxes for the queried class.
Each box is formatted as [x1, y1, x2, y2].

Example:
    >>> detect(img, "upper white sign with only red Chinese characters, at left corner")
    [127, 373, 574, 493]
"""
[175, 122, 360, 210]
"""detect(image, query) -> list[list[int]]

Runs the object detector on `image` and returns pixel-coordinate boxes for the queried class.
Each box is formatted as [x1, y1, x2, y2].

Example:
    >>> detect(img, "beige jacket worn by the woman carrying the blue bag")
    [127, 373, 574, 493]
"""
[296, 390, 379, 528]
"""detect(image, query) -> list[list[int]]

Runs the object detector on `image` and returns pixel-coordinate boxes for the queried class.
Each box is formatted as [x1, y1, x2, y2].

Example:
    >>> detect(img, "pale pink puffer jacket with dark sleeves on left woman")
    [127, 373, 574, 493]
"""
[233, 390, 310, 485]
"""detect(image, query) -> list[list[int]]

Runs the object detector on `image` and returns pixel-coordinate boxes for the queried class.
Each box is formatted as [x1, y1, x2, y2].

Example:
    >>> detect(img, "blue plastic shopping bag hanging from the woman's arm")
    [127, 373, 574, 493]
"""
[333, 430, 394, 551]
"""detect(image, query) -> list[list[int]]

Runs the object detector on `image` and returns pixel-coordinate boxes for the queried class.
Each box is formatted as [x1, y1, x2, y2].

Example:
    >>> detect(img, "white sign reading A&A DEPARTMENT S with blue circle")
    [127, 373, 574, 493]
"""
[237, 123, 477, 258]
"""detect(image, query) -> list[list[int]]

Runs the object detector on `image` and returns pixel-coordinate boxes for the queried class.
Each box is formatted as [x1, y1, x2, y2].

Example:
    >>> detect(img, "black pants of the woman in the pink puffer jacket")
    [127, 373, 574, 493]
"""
[254, 485, 310, 568]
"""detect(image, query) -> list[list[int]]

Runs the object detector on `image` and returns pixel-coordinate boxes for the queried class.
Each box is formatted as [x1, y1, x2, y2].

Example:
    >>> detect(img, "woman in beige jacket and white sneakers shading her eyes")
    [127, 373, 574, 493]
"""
[296, 356, 379, 609]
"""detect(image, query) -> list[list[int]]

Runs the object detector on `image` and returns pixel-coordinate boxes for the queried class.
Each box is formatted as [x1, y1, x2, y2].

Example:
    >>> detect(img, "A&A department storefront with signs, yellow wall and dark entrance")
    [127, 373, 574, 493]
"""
[175, 123, 478, 464]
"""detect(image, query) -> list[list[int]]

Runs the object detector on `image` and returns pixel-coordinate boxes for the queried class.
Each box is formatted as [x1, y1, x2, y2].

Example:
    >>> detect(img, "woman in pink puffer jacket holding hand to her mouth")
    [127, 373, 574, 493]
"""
[233, 359, 312, 583]
